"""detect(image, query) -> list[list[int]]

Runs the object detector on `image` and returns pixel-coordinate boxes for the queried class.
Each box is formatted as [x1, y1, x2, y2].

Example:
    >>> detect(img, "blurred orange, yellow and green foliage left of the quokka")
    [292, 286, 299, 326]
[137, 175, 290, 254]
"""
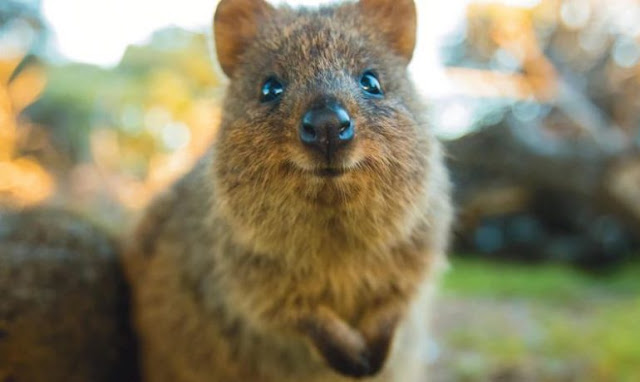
[0, 1, 220, 221]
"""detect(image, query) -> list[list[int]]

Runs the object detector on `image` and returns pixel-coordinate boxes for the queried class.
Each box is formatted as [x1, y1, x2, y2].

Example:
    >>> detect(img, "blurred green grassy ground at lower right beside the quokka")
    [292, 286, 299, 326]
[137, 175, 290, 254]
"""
[430, 261, 640, 382]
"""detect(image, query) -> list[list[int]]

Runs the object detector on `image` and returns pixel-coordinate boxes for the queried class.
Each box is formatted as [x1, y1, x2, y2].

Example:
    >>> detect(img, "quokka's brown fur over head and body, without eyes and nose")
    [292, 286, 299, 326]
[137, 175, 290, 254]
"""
[127, 0, 451, 382]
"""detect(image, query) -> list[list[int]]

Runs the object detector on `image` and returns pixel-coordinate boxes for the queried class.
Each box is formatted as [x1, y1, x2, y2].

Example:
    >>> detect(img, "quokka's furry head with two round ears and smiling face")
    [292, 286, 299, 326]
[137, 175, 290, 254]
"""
[214, 0, 429, 209]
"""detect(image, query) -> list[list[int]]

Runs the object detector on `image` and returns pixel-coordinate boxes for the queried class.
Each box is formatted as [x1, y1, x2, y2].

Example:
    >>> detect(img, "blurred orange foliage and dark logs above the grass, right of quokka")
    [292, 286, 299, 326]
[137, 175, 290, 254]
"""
[434, 0, 640, 269]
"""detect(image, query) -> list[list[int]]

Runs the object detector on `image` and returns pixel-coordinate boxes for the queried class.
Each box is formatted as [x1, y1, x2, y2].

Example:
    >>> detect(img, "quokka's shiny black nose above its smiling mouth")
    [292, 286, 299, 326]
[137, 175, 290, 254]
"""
[300, 102, 355, 161]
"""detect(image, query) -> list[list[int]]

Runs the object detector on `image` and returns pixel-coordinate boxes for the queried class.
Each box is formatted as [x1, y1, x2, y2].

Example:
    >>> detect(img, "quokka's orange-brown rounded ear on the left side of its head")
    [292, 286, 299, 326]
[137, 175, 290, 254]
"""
[213, 0, 274, 77]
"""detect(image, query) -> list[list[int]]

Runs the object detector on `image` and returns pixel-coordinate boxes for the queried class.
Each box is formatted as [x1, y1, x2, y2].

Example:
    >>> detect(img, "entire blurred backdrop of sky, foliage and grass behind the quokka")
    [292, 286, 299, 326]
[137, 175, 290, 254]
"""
[0, 0, 640, 381]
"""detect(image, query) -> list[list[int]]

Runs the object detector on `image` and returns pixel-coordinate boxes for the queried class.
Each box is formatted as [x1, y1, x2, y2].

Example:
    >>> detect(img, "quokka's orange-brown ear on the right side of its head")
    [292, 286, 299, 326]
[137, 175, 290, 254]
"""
[358, 0, 418, 61]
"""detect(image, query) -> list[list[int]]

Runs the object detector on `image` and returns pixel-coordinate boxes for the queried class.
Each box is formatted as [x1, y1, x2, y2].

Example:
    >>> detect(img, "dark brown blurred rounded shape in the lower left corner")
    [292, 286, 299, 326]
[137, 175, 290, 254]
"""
[0, 208, 138, 382]
